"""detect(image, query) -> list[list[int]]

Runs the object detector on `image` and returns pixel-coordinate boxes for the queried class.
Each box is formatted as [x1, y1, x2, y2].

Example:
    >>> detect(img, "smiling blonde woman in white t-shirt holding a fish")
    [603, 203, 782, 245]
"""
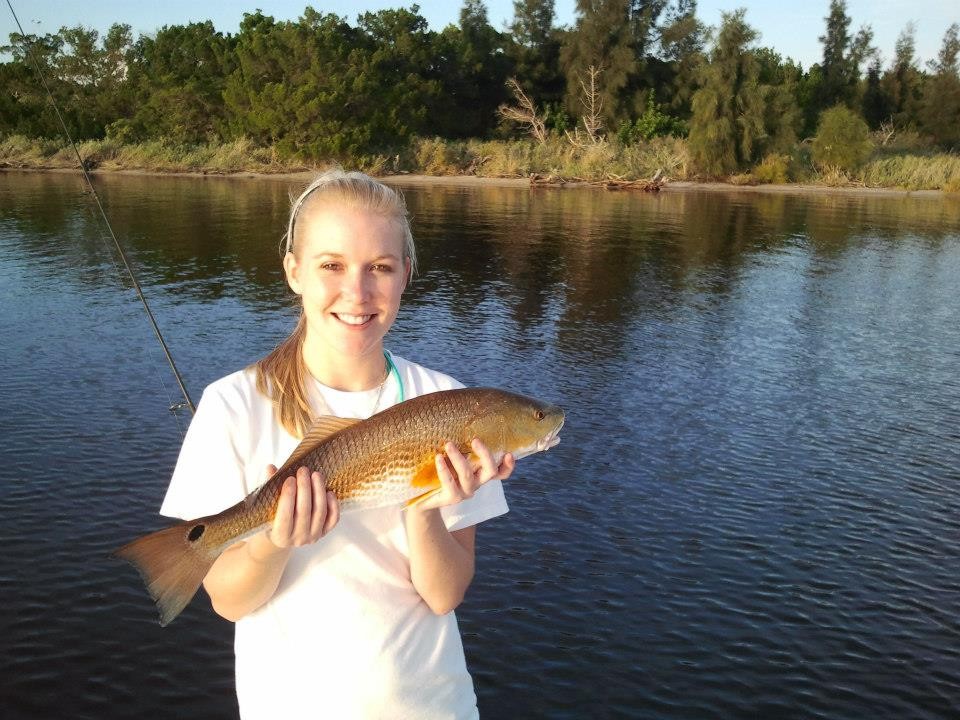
[161, 171, 514, 720]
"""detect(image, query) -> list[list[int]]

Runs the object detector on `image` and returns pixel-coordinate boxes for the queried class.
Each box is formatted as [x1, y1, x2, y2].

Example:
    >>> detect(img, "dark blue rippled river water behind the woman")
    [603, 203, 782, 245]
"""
[0, 172, 960, 720]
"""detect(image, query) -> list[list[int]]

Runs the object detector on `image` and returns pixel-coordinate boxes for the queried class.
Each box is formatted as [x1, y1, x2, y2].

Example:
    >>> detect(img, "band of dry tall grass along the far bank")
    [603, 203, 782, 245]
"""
[0, 135, 960, 192]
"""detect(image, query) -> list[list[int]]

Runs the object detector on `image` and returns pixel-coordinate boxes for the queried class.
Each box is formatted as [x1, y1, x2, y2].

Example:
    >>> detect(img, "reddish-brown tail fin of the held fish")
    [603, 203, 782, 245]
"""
[113, 523, 219, 626]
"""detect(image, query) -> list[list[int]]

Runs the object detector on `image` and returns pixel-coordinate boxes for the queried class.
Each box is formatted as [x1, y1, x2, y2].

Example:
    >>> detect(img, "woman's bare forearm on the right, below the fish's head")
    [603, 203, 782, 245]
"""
[406, 508, 476, 615]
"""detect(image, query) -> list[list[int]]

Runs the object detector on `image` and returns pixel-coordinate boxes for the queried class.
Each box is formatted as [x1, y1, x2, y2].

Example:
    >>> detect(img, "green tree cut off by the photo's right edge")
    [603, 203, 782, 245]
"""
[920, 23, 960, 150]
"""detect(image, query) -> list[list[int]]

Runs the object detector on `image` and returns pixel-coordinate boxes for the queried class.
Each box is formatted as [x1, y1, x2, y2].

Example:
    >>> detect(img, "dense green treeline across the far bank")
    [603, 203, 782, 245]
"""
[0, 0, 960, 175]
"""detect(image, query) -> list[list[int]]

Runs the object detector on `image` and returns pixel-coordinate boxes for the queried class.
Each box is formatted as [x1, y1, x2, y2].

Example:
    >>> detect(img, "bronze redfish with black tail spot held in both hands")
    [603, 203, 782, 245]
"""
[114, 388, 564, 625]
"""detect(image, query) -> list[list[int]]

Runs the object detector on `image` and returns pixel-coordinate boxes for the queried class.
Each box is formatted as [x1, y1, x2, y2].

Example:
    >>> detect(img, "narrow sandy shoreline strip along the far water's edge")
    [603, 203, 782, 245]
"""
[0, 167, 956, 198]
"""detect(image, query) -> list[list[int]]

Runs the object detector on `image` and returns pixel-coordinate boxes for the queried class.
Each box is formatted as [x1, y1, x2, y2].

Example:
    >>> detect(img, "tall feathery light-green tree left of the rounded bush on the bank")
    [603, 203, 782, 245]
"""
[690, 9, 766, 175]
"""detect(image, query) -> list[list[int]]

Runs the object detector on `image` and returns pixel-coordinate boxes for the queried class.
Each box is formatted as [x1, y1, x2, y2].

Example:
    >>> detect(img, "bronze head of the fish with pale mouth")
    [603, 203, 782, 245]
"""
[470, 390, 564, 459]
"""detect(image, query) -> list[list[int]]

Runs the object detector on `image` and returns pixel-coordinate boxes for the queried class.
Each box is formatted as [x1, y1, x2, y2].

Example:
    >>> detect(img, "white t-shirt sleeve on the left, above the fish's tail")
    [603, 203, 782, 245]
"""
[160, 384, 245, 520]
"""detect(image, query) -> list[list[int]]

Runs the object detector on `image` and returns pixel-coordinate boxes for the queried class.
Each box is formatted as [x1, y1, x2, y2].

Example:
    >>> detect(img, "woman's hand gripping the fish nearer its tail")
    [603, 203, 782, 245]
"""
[267, 465, 340, 548]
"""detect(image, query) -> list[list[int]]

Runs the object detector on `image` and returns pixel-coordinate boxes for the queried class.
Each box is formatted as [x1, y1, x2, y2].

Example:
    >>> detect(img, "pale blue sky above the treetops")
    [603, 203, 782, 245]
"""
[0, 0, 960, 68]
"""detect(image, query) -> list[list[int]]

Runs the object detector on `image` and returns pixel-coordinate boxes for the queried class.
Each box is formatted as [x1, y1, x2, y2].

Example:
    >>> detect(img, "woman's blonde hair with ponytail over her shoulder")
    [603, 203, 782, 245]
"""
[254, 169, 417, 438]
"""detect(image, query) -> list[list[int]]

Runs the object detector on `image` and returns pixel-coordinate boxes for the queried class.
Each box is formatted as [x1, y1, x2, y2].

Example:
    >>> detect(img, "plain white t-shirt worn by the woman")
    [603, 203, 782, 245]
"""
[160, 356, 507, 720]
